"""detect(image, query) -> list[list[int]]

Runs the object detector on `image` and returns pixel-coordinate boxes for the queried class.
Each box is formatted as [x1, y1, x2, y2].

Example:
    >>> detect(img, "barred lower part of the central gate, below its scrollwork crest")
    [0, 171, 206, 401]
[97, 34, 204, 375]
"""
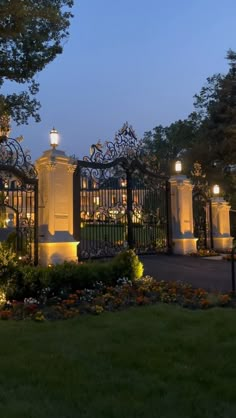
[74, 162, 170, 260]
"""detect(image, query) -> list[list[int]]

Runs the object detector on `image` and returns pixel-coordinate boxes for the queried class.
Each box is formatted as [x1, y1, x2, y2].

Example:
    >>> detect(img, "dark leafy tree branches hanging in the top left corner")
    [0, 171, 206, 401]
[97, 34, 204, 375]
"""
[0, 0, 73, 124]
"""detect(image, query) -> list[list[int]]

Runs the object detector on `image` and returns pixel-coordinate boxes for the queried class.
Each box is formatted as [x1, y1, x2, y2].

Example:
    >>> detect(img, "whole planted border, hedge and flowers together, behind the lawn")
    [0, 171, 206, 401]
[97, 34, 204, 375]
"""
[0, 250, 236, 321]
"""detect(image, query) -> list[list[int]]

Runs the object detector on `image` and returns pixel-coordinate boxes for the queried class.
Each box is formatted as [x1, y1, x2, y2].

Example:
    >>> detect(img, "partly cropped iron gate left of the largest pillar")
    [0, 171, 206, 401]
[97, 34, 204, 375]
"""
[0, 136, 38, 264]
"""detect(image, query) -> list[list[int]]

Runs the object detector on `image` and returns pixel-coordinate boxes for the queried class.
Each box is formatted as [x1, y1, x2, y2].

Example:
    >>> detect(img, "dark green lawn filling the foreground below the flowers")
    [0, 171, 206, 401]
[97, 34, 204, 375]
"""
[0, 304, 236, 418]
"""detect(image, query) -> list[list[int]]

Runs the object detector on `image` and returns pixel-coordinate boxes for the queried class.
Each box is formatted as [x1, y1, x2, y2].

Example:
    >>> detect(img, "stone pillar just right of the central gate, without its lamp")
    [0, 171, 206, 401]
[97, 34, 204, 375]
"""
[169, 174, 197, 255]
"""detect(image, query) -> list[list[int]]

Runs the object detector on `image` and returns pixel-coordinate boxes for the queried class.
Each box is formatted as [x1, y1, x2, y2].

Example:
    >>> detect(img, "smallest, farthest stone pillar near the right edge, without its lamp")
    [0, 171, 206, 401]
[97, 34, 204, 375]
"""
[211, 197, 233, 252]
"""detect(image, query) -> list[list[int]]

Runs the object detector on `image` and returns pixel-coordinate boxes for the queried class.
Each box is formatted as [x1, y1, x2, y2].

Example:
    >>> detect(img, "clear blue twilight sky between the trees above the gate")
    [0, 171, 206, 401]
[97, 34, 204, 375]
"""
[8, 0, 236, 161]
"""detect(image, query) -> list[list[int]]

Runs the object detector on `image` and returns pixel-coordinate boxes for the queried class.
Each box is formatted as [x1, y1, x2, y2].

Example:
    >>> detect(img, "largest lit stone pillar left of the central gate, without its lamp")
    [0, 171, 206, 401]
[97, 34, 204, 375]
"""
[36, 147, 78, 265]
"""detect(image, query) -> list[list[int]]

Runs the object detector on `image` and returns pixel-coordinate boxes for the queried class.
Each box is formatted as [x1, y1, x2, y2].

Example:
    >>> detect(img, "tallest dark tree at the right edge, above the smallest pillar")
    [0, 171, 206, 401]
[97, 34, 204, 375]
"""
[189, 50, 236, 206]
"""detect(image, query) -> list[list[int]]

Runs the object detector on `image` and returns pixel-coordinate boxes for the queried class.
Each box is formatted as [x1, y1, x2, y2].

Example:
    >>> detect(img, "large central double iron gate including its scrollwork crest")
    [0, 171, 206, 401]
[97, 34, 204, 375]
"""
[74, 124, 170, 259]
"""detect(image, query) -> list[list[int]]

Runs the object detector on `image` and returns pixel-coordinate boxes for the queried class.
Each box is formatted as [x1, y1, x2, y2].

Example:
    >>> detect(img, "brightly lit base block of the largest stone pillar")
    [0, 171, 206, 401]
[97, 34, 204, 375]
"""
[39, 241, 79, 266]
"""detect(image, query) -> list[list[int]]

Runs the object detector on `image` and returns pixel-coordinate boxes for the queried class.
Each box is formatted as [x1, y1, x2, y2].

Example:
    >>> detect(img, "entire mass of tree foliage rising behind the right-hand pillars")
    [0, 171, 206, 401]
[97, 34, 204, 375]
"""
[144, 50, 236, 206]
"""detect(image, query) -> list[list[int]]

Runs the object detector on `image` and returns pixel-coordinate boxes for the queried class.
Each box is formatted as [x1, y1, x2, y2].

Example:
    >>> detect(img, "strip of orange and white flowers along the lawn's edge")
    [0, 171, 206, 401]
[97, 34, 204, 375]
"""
[0, 276, 236, 322]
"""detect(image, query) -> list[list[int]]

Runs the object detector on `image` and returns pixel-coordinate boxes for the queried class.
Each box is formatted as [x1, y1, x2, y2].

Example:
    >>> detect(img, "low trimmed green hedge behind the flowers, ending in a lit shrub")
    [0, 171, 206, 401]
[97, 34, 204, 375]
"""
[0, 250, 143, 300]
